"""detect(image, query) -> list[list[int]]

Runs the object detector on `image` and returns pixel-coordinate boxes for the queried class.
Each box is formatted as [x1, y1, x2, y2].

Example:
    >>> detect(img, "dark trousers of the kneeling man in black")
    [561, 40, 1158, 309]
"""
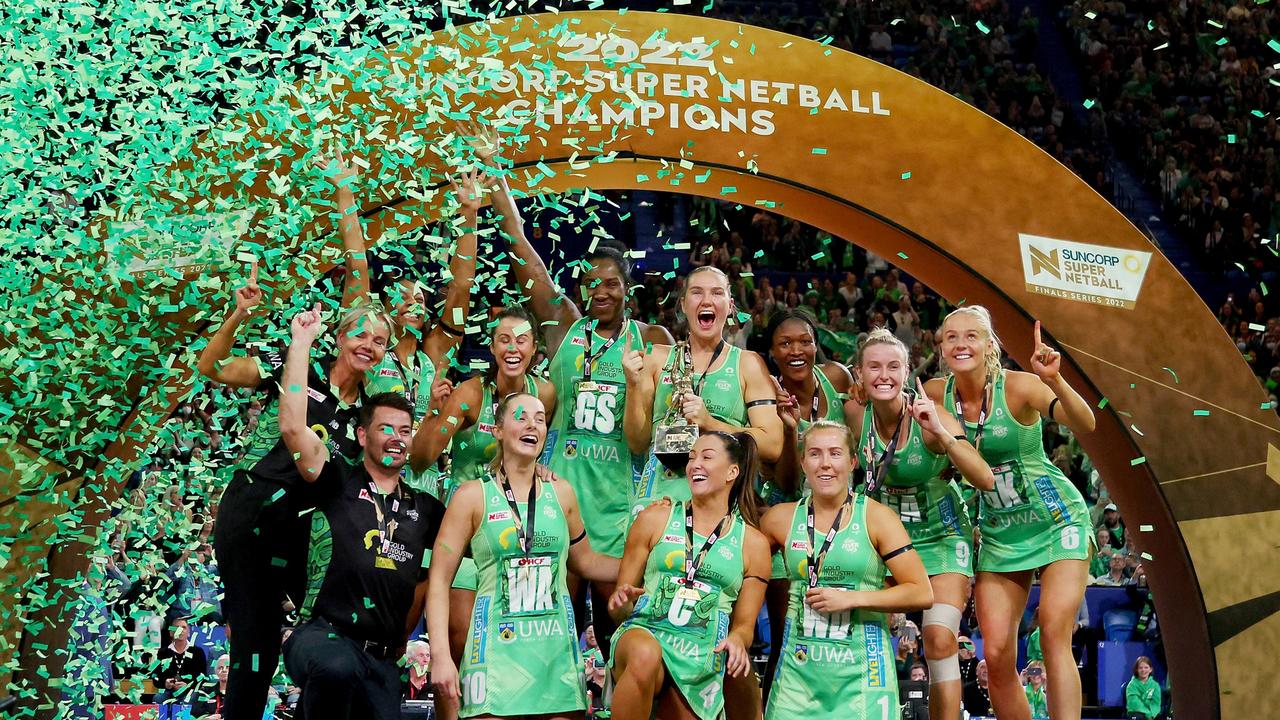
[284, 618, 402, 720]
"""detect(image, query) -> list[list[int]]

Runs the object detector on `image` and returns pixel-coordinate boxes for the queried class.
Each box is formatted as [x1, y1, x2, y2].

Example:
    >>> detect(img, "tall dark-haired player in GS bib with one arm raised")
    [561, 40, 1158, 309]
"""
[494, 172, 672, 657]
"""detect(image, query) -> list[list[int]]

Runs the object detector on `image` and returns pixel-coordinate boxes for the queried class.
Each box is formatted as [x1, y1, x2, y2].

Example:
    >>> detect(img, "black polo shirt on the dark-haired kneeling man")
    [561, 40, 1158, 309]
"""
[308, 459, 444, 646]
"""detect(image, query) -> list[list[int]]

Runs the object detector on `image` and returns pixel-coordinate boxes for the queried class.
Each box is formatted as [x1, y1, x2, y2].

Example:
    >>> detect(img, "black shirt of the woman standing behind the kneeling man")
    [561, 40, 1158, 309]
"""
[236, 350, 365, 486]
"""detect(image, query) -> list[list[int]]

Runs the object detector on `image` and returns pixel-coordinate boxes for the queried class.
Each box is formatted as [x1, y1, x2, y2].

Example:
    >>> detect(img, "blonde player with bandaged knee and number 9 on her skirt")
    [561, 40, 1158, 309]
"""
[845, 328, 996, 717]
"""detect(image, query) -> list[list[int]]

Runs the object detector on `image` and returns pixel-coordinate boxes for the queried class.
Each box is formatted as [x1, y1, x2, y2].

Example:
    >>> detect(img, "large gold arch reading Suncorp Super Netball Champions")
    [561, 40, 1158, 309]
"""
[4, 12, 1280, 719]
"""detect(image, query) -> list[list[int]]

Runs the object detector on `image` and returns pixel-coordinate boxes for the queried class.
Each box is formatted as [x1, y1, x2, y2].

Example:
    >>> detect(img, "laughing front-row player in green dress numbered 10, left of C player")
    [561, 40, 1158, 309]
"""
[426, 392, 618, 720]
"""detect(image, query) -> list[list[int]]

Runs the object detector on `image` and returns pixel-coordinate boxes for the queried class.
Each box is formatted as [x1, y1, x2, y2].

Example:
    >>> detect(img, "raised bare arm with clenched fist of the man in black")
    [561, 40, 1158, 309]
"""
[279, 302, 329, 483]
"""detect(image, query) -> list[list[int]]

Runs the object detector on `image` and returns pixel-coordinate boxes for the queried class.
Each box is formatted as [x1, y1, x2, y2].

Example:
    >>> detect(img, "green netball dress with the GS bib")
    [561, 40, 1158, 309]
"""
[543, 318, 644, 557]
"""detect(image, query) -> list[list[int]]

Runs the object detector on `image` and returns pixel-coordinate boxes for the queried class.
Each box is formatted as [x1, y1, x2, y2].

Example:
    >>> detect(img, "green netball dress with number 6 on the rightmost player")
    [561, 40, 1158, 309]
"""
[943, 372, 1093, 573]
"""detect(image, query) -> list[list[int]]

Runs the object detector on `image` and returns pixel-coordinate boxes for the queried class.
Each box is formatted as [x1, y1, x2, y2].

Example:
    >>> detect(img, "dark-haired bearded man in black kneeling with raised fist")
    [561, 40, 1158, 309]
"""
[279, 310, 444, 720]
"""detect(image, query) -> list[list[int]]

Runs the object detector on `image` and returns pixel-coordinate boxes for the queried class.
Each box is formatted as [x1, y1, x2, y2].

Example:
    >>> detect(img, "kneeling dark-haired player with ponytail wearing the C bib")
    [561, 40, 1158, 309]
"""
[609, 430, 769, 720]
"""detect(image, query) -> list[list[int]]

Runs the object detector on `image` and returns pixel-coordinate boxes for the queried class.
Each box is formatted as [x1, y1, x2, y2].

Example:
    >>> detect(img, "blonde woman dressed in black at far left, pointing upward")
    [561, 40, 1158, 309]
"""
[197, 269, 392, 717]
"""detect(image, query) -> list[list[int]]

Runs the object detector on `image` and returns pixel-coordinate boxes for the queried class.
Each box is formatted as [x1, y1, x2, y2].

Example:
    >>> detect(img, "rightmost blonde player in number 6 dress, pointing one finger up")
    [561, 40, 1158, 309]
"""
[925, 305, 1094, 720]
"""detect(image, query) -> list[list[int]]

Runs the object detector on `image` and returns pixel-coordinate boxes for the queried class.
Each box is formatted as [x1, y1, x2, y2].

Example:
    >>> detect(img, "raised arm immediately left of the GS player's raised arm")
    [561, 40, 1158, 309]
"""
[422, 170, 485, 375]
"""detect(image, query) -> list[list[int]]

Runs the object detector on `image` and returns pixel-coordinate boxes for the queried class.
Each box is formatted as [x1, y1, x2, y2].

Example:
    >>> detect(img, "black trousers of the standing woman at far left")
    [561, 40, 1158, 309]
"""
[214, 471, 311, 720]
